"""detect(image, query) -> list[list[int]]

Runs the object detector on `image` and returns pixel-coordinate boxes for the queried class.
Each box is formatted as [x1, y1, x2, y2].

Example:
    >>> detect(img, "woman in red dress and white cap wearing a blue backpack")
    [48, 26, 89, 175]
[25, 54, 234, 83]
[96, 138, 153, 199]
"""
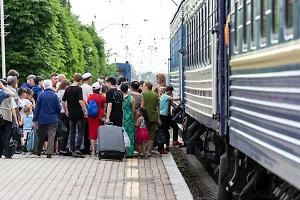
[87, 82, 106, 155]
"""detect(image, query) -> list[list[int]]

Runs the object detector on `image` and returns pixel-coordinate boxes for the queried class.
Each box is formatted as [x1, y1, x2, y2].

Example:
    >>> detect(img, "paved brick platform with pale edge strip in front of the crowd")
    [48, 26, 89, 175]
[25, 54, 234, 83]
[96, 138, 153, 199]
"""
[0, 154, 193, 200]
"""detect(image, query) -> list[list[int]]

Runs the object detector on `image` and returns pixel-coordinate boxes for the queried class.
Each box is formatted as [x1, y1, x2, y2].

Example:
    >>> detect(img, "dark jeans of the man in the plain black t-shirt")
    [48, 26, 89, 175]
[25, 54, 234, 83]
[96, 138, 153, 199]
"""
[69, 119, 84, 152]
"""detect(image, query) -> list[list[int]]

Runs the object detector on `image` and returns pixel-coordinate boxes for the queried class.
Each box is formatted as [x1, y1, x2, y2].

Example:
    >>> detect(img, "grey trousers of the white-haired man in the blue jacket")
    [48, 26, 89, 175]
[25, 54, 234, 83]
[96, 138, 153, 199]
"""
[37, 122, 57, 155]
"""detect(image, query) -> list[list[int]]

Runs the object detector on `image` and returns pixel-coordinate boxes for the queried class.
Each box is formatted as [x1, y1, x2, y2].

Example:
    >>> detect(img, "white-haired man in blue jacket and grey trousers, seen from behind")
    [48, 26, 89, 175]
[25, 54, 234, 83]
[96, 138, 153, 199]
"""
[32, 79, 61, 158]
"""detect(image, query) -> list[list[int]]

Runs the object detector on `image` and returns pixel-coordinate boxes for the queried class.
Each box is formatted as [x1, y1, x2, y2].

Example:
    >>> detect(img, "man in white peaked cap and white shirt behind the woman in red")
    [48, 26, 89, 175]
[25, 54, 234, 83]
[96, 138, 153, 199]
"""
[81, 72, 93, 154]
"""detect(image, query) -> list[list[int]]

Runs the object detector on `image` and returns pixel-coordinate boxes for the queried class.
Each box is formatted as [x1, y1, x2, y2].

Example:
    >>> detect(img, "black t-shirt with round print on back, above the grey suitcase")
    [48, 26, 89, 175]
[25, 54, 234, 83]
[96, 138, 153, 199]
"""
[106, 88, 123, 115]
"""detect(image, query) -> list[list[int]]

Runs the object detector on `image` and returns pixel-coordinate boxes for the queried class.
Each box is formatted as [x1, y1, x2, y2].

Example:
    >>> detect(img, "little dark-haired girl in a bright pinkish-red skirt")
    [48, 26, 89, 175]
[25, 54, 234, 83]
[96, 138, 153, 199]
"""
[135, 107, 150, 157]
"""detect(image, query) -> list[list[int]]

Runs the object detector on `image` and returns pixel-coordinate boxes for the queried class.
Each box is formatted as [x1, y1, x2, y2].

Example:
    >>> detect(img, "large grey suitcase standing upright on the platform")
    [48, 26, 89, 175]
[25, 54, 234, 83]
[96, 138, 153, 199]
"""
[97, 125, 125, 161]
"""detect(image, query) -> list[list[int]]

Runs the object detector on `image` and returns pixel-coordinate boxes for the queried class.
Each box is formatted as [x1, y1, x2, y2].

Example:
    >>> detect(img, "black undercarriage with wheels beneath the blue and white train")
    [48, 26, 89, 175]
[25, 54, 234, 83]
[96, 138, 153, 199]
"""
[174, 112, 300, 200]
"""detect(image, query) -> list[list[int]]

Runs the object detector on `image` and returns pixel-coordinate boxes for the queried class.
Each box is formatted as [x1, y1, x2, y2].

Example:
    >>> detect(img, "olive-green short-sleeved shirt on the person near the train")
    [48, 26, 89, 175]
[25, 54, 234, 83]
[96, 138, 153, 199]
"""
[142, 90, 159, 123]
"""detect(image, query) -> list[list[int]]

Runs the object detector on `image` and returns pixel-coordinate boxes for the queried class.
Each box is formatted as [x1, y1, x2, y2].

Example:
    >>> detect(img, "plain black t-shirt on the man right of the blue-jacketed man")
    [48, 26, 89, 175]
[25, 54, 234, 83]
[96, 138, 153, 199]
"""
[62, 86, 84, 121]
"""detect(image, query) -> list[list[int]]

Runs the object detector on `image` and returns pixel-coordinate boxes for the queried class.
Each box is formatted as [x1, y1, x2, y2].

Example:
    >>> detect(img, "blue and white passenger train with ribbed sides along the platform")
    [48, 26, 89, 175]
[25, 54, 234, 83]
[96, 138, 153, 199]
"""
[169, 0, 300, 200]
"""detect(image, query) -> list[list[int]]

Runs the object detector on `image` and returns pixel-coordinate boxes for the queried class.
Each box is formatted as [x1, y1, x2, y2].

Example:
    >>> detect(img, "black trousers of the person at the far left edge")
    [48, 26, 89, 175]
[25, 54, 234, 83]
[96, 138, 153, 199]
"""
[0, 120, 12, 156]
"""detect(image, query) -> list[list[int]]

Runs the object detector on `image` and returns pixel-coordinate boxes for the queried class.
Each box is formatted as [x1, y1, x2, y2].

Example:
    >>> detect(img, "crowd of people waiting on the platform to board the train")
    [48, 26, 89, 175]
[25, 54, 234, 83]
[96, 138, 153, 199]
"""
[0, 70, 182, 159]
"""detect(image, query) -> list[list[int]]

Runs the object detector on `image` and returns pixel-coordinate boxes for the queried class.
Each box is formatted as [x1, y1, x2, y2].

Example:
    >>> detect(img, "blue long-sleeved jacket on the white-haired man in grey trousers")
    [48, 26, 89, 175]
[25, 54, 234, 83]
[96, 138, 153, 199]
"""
[32, 89, 61, 124]
